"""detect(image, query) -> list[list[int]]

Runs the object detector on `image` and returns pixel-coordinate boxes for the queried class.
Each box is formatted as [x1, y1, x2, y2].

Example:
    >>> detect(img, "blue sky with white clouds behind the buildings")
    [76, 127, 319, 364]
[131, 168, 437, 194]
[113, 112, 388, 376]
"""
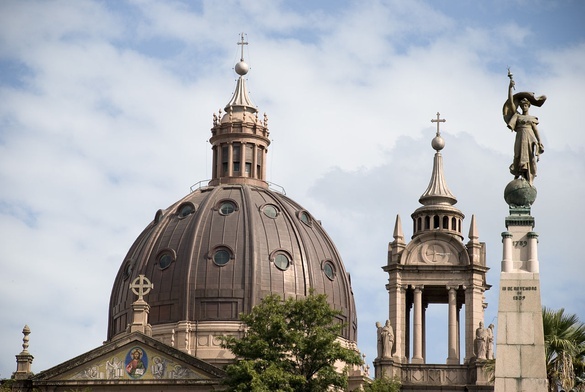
[0, 0, 585, 377]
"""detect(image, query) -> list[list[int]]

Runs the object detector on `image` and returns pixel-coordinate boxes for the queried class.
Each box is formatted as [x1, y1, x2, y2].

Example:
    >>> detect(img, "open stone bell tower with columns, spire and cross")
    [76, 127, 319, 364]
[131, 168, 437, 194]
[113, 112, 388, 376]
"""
[374, 113, 493, 391]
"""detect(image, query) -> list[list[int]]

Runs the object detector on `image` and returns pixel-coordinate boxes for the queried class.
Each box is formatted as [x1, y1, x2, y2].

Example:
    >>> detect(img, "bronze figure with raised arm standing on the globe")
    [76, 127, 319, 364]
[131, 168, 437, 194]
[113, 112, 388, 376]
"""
[503, 69, 546, 185]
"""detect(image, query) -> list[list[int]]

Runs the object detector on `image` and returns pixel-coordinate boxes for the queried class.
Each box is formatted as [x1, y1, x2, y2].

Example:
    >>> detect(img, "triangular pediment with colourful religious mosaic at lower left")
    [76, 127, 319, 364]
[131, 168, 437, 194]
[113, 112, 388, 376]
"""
[33, 332, 225, 384]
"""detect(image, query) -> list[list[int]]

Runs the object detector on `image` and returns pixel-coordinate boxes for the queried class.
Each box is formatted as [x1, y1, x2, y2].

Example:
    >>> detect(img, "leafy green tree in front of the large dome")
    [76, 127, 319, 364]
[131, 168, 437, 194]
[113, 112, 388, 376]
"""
[222, 293, 362, 392]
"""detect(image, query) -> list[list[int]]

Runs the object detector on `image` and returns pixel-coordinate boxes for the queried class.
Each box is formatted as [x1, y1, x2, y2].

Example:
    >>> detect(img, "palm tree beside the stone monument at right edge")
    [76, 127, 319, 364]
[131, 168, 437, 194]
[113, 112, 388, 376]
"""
[542, 307, 585, 391]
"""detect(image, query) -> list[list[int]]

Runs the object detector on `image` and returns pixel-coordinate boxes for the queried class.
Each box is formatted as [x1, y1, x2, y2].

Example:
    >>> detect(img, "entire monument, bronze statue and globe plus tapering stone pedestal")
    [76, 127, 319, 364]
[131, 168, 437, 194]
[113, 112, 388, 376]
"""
[494, 72, 548, 392]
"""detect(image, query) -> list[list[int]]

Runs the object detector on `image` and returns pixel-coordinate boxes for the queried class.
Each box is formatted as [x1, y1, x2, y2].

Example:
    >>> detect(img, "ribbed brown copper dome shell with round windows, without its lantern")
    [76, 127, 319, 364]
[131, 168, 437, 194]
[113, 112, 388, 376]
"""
[108, 184, 357, 341]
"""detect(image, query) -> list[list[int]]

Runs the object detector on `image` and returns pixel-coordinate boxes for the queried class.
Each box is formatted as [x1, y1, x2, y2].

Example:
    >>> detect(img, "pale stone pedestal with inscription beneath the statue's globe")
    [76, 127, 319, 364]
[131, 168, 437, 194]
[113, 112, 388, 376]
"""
[494, 199, 547, 392]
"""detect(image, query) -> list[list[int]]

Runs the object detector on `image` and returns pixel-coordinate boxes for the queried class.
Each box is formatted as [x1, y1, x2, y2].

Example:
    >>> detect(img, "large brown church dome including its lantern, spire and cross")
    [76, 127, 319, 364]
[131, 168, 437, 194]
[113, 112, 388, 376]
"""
[108, 36, 357, 355]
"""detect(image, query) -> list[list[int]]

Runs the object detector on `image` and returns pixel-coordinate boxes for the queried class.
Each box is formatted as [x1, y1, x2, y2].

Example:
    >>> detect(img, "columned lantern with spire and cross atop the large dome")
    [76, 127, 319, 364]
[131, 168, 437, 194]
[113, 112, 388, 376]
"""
[209, 33, 270, 188]
